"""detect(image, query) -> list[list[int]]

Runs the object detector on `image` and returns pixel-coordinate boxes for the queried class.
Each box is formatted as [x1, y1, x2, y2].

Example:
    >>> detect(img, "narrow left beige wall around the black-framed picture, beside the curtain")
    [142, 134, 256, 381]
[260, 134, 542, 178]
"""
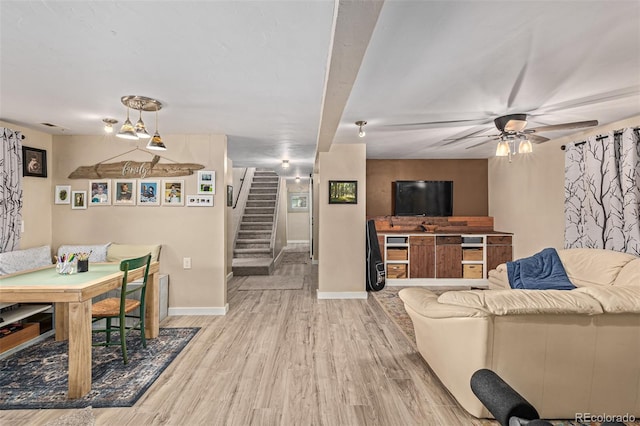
[0, 121, 54, 249]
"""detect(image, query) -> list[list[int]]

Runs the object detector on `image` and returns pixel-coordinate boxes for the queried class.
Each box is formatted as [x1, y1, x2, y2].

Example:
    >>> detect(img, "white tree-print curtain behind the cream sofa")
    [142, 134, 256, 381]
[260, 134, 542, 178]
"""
[564, 129, 640, 255]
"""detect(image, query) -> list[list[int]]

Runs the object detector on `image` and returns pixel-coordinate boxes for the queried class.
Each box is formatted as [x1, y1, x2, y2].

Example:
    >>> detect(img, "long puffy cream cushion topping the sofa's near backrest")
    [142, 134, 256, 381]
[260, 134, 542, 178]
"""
[438, 290, 602, 315]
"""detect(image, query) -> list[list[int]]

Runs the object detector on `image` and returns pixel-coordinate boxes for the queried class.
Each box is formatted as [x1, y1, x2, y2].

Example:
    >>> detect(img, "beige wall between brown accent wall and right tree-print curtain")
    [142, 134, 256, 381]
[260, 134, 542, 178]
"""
[489, 116, 640, 259]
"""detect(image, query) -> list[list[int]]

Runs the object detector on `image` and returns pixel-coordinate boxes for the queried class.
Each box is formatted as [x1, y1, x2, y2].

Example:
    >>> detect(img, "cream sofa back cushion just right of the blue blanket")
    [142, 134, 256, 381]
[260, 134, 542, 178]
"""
[558, 248, 637, 287]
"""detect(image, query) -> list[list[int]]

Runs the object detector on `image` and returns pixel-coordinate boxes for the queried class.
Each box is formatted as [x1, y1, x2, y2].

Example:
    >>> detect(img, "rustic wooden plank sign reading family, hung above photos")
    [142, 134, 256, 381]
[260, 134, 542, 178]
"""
[69, 155, 204, 179]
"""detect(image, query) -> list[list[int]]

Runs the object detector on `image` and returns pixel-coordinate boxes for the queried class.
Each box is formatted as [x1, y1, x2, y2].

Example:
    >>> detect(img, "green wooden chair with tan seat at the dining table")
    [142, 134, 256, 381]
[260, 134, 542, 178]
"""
[91, 254, 151, 364]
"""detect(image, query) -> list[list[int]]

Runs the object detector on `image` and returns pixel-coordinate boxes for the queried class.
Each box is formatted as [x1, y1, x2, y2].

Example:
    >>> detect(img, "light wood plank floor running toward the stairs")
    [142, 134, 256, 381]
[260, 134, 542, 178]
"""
[0, 255, 497, 426]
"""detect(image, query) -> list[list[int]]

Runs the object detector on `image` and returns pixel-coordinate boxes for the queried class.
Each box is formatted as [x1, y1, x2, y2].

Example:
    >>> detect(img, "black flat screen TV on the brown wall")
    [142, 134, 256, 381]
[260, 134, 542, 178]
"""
[394, 180, 453, 216]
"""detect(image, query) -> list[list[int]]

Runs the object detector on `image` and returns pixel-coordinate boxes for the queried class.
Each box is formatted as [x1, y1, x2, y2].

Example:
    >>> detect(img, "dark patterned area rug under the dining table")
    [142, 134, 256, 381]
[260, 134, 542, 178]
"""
[0, 328, 200, 410]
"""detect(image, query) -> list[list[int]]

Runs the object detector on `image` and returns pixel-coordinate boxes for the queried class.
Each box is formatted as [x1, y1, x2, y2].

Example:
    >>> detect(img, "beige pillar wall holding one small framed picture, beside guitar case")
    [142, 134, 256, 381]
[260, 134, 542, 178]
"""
[318, 144, 367, 298]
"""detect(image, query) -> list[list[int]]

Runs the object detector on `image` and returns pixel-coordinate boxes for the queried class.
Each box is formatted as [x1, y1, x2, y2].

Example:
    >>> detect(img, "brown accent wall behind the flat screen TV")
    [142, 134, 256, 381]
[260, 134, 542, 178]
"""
[367, 159, 489, 217]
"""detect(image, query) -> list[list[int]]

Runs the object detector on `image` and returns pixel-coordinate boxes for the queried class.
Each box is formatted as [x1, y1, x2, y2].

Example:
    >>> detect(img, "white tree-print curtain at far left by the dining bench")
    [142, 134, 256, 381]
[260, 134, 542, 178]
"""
[0, 127, 22, 253]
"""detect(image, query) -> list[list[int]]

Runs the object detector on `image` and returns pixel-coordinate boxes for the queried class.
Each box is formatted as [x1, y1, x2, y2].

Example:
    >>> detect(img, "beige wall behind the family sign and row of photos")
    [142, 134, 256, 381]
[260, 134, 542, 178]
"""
[48, 135, 229, 314]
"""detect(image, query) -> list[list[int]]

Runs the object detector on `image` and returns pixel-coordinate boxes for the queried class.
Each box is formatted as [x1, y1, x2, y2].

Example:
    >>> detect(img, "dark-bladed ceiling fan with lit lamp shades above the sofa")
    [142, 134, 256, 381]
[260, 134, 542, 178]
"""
[444, 113, 598, 157]
